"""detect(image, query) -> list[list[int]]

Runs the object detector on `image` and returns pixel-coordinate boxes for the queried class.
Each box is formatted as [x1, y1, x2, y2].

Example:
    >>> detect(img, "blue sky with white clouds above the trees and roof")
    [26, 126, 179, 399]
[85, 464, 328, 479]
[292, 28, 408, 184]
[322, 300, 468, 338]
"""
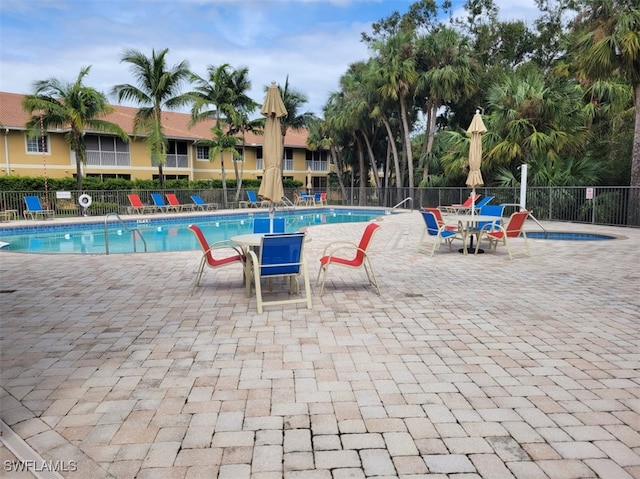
[0, 0, 538, 115]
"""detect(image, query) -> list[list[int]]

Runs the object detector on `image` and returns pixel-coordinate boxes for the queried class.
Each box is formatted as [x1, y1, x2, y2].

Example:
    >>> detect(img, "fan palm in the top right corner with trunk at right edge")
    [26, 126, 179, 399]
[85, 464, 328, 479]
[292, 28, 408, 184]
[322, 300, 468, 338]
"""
[572, 0, 640, 189]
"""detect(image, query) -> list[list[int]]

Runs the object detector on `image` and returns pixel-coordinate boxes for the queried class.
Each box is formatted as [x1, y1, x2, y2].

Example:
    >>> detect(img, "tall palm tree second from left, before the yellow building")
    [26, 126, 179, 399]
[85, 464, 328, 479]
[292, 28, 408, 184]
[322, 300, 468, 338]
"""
[112, 48, 192, 189]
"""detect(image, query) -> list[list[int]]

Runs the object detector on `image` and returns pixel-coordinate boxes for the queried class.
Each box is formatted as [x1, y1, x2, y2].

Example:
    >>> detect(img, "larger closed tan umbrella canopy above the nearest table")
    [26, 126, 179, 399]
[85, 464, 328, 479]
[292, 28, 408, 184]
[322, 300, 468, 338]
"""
[258, 82, 287, 203]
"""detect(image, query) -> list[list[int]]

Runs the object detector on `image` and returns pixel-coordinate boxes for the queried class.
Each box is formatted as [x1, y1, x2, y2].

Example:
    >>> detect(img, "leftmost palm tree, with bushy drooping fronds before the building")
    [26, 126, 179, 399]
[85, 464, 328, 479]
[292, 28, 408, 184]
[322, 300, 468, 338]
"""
[22, 66, 129, 192]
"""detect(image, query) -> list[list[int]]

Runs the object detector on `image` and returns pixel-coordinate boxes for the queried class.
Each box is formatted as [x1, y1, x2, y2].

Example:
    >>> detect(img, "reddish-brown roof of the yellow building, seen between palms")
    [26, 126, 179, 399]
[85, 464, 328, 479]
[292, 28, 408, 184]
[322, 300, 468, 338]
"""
[0, 92, 308, 148]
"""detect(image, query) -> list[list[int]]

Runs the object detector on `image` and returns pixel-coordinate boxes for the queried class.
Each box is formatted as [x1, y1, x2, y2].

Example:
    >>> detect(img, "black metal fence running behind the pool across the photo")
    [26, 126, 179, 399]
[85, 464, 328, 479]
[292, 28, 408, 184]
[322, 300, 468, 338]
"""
[0, 187, 640, 227]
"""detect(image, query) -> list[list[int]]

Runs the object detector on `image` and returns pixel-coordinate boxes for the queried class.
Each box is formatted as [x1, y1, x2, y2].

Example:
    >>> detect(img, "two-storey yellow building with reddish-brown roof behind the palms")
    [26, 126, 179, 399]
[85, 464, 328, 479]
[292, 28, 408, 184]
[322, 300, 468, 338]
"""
[0, 92, 330, 190]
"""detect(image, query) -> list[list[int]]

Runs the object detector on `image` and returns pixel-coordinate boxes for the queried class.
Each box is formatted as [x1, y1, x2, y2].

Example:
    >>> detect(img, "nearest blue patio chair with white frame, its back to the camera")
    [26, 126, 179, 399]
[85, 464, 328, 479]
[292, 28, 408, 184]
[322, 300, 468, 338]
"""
[247, 233, 311, 313]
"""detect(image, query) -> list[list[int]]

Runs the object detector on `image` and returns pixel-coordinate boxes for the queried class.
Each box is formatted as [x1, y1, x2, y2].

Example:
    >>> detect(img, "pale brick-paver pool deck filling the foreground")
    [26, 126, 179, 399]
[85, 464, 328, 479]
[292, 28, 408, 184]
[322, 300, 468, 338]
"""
[0, 212, 640, 479]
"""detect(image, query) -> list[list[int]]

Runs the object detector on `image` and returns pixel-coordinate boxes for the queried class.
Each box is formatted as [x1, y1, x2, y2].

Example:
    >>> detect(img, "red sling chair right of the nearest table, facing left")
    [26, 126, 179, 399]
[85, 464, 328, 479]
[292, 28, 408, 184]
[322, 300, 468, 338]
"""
[316, 223, 380, 295]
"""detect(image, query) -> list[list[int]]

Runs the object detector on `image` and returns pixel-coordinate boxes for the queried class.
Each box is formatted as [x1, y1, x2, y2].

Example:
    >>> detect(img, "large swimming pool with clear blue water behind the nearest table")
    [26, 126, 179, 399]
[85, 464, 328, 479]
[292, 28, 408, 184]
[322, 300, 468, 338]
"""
[0, 208, 386, 254]
